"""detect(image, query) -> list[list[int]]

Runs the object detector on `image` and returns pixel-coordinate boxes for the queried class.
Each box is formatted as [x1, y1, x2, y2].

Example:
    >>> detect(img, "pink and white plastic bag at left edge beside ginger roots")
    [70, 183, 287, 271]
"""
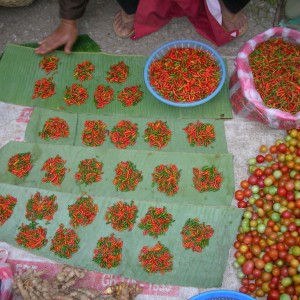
[0, 249, 13, 300]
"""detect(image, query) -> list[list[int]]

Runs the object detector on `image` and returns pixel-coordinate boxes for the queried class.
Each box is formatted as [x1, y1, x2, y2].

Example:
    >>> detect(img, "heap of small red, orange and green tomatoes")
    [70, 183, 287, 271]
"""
[233, 129, 300, 300]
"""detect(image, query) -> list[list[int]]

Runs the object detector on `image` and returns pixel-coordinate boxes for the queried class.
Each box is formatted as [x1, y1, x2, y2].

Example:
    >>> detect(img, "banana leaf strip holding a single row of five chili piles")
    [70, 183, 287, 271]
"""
[25, 108, 227, 154]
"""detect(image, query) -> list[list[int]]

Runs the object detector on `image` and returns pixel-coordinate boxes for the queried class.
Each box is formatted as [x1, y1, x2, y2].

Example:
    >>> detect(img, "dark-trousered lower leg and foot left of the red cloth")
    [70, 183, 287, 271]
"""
[113, 0, 139, 38]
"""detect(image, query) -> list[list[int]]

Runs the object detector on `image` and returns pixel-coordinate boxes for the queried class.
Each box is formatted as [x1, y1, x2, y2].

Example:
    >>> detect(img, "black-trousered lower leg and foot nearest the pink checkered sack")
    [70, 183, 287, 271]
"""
[219, 0, 250, 36]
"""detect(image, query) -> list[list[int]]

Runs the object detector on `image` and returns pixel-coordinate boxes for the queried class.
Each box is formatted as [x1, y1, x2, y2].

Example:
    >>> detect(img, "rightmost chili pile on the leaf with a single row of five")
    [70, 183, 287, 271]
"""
[183, 121, 216, 147]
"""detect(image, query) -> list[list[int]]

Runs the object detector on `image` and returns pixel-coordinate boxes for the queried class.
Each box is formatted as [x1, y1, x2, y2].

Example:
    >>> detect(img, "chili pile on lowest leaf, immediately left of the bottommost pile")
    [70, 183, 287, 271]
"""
[93, 233, 123, 269]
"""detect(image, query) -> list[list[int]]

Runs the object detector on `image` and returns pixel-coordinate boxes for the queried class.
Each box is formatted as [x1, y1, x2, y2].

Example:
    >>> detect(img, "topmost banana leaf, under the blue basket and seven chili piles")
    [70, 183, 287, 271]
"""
[0, 44, 232, 119]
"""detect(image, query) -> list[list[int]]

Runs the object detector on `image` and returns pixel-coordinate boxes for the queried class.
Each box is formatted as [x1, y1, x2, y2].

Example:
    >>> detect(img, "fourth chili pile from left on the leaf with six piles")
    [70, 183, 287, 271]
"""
[113, 161, 143, 192]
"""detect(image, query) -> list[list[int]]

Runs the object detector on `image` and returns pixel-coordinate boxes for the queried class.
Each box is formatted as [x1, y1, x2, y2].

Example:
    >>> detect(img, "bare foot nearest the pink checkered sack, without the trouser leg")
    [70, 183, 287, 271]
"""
[220, 0, 248, 36]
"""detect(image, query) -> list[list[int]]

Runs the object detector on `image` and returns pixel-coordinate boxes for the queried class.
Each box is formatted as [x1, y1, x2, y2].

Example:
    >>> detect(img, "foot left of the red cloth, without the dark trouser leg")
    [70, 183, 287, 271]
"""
[113, 10, 135, 38]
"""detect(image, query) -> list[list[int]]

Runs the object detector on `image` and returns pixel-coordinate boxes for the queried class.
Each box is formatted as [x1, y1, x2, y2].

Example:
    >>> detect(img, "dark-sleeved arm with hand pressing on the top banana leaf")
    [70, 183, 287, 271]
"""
[35, 0, 88, 54]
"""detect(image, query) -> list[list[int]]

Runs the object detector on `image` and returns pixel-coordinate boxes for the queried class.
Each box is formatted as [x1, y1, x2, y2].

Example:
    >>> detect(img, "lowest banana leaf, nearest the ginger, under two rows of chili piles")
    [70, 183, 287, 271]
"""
[0, 183, 242, 288]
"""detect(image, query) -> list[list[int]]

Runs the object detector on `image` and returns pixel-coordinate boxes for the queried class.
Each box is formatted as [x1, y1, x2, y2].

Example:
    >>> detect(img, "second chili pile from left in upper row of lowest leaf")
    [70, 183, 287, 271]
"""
[26, 192, 58, 222]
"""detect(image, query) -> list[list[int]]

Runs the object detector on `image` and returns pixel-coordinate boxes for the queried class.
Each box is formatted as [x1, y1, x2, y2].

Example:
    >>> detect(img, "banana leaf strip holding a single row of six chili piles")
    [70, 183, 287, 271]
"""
[0, 141, 234, 206]
